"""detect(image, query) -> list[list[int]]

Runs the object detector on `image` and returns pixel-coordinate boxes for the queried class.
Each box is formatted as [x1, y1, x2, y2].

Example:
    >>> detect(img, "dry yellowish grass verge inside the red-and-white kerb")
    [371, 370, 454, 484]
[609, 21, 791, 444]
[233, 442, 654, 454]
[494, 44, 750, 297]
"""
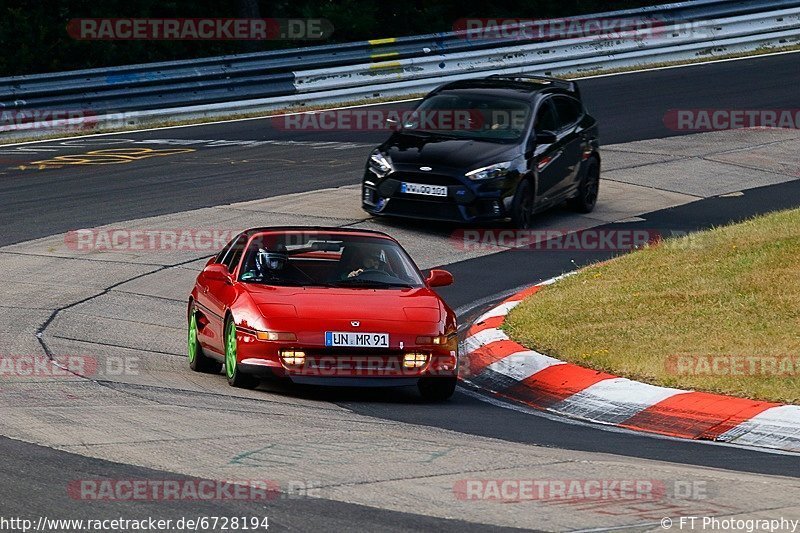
[503, 209, 800, 404]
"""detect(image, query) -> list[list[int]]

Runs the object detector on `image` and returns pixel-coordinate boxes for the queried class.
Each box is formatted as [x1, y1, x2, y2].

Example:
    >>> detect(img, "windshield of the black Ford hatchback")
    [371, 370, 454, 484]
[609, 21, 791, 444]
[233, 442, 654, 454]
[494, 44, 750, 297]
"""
[401, 93, 531, 142]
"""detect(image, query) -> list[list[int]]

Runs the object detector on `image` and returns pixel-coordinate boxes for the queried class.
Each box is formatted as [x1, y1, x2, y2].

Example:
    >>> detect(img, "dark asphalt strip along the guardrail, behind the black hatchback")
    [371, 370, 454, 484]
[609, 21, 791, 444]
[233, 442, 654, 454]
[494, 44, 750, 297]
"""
[0, 50, 798, 245]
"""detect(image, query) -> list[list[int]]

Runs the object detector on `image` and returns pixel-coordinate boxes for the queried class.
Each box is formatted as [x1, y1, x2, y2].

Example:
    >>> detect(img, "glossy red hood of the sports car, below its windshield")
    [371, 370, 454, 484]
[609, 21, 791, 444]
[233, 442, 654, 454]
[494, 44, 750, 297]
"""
[247, 284, 442, 322]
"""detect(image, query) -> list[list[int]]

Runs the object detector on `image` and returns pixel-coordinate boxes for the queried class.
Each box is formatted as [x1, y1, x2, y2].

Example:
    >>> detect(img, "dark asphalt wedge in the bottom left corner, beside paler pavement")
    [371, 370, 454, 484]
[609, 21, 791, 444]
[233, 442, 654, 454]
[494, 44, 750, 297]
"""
[0, 437, 528, 532]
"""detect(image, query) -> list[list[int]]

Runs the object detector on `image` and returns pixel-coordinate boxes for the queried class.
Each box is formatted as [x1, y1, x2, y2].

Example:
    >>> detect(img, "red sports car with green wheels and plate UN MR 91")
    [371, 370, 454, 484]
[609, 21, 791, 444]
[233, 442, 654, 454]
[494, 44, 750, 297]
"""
[188, 227, 458, 400]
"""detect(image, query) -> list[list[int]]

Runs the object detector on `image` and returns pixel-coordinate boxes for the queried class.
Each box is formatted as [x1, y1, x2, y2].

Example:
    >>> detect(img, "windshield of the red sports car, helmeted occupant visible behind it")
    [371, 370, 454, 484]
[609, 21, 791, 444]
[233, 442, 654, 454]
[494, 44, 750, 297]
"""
[239, 231, 424, 288]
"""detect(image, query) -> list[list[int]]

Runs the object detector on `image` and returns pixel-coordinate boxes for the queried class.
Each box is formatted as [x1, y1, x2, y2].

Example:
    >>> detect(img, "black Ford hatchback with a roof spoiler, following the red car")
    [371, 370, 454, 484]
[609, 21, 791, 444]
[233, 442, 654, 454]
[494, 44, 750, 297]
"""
[362, 75, 600, 228]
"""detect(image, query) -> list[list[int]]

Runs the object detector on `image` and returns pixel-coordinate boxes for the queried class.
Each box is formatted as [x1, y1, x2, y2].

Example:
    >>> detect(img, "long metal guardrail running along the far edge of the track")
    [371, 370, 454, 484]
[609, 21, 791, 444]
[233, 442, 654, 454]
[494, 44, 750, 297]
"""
[0, 0, 800, 133]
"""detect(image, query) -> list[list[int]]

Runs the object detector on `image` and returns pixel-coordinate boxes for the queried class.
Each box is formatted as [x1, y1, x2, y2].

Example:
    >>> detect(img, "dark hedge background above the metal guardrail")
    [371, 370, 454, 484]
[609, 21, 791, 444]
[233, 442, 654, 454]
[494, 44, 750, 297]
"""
[0, 0, 662, 76]
